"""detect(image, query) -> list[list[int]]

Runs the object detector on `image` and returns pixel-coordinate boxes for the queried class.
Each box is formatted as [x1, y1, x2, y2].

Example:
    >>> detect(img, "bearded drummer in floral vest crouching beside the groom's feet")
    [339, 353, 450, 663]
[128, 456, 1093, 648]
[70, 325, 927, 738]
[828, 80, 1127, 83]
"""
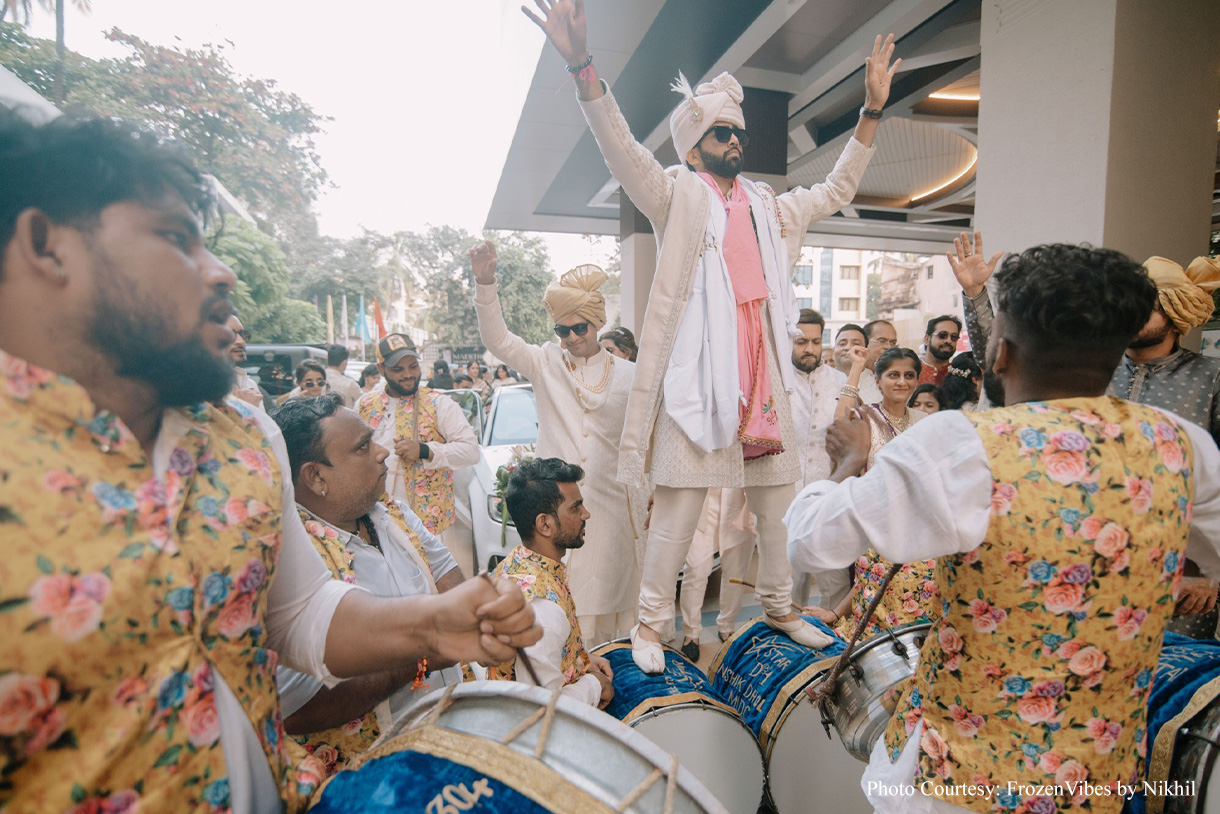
[487, 456, 614, 709]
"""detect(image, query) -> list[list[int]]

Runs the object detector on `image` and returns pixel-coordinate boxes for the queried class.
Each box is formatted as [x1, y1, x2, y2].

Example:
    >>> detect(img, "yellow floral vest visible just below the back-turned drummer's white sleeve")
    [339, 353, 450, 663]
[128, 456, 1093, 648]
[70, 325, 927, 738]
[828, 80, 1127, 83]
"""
[834, 548, 941, 639]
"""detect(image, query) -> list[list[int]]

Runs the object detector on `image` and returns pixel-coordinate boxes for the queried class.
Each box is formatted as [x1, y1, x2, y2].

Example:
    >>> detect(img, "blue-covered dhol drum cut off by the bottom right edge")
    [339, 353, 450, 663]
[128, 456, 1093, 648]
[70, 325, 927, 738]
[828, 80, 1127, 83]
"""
[1129, 633, 1220, 814]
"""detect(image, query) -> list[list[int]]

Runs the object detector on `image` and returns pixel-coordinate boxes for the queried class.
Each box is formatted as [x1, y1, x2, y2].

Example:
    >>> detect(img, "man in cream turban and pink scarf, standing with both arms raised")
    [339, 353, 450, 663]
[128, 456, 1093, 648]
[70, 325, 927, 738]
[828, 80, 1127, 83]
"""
[525, 0, 898, 672]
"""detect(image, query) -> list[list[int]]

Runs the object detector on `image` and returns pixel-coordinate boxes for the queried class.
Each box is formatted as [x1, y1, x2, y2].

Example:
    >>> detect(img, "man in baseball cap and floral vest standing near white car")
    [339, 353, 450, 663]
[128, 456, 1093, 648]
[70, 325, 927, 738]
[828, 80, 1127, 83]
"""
[356, 333, 478, 566]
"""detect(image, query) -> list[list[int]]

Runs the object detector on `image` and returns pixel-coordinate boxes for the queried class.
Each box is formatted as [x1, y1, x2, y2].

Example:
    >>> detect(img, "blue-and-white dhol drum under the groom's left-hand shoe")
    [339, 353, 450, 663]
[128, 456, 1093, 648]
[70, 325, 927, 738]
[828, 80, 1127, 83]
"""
[593, 641, 765, 814]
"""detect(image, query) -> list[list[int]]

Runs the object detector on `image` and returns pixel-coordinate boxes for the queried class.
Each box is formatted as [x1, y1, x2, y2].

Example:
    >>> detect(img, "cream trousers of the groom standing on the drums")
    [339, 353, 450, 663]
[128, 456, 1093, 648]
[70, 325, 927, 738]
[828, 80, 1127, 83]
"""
[639, 483, 794, 631]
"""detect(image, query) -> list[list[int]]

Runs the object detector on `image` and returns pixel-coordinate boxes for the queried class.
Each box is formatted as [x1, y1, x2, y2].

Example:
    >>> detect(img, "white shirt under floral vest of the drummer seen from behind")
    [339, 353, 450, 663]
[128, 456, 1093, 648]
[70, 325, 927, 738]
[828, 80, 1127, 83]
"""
[783, 410, 1220, 814]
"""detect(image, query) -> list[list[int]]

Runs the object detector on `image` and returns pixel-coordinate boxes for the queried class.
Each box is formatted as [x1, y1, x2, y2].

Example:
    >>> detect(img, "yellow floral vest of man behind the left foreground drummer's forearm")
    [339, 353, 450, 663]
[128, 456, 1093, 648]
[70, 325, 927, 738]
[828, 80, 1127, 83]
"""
[290, 500, 431, 777]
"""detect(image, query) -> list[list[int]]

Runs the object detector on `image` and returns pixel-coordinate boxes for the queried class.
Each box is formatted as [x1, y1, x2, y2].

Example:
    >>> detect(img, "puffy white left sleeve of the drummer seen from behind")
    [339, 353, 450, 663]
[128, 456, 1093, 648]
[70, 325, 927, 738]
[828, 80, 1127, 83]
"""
[784, 411, 992, 571]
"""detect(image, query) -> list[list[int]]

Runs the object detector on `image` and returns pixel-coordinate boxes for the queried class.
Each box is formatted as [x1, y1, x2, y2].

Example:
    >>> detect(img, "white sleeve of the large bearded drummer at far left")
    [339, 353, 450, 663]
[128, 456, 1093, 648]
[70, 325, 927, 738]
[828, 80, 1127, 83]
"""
[253, 410, 355, 687]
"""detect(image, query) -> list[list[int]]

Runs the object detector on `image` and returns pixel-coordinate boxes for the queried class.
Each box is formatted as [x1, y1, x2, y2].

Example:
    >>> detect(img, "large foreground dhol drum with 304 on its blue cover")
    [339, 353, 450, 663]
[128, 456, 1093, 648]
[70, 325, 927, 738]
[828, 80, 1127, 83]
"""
[311, 681, 727, 814]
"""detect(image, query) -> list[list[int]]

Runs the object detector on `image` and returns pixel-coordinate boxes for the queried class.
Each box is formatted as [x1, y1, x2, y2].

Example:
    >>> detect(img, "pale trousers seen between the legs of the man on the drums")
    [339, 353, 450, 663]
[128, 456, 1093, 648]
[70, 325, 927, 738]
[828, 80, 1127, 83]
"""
[680, 488, 756, 642]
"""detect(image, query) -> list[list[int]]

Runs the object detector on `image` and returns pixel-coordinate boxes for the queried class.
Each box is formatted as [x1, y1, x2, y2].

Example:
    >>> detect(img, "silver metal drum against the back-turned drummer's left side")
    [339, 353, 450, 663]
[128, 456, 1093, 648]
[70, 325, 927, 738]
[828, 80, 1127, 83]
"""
[830, 624, 932, 763]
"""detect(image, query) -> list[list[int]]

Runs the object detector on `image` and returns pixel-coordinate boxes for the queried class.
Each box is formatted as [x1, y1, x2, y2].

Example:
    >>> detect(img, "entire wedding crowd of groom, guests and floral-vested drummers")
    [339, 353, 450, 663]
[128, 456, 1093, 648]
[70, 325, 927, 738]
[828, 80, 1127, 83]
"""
[7, 0, 1220, 813]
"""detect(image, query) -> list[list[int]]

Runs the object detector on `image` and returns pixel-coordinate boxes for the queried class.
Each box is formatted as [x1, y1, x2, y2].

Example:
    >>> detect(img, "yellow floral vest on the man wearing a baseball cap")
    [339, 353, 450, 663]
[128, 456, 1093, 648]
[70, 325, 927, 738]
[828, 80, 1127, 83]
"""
[356, 387, 458, 535]
